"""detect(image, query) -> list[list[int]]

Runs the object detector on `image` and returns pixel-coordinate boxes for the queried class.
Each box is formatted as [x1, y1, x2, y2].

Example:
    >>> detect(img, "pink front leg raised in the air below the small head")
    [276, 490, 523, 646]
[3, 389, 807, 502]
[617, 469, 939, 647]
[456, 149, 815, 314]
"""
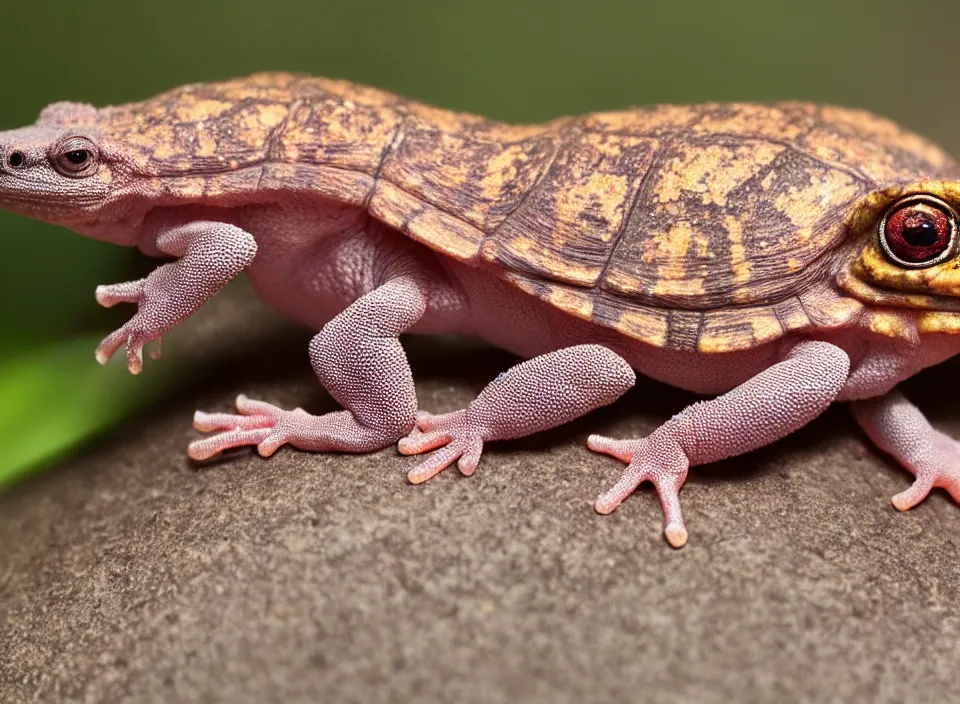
[96, 222, 257, 374]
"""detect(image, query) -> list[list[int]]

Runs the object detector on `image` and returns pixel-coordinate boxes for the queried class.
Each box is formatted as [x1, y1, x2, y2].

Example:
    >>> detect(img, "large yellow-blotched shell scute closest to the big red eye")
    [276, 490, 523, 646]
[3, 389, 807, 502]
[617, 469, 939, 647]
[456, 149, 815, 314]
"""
[601, 138, 866, 309]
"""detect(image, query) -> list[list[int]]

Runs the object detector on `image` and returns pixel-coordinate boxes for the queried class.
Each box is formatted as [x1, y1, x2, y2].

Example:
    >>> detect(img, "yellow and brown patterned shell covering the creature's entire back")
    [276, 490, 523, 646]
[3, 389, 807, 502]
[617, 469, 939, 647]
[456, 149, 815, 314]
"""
[88, 74, 957, 352]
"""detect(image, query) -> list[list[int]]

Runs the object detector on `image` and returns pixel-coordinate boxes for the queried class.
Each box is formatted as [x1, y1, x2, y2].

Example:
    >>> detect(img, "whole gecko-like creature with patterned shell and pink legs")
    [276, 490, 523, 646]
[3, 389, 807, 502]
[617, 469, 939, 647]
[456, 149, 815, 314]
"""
[0, 76, 960, 547]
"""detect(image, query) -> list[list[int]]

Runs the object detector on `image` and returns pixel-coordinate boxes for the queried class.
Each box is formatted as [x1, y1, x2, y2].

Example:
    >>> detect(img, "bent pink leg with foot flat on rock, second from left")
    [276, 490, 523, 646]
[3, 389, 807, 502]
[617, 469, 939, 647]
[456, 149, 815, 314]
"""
[188, 275, 427, 460]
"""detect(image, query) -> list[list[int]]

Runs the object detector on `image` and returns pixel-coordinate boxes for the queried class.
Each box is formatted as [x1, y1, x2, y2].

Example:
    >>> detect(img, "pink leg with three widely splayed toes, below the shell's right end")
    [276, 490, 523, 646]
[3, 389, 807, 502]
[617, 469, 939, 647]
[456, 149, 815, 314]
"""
[587, 341, 850, 548]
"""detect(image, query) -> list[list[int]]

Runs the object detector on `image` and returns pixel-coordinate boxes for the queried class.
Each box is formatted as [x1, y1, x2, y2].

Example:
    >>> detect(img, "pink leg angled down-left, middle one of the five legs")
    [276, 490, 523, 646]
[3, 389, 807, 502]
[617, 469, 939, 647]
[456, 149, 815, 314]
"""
[398, 345, 636, 484]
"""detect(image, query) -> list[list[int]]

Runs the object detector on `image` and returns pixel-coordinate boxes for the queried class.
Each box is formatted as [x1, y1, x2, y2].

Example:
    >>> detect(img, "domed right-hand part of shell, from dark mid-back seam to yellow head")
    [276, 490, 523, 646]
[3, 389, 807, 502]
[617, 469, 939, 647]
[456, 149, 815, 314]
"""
[362, 97, 957, 353]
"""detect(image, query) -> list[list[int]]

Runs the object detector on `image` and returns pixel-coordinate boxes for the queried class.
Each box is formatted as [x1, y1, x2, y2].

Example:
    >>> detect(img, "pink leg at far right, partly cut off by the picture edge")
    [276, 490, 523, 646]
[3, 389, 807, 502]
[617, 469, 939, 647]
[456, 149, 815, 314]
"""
[850, 390, 960, 511]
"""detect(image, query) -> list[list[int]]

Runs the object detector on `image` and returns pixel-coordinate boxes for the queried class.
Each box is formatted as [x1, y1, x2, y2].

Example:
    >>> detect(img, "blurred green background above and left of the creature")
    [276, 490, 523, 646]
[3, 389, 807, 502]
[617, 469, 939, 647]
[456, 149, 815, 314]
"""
[0, 0, 960, 485]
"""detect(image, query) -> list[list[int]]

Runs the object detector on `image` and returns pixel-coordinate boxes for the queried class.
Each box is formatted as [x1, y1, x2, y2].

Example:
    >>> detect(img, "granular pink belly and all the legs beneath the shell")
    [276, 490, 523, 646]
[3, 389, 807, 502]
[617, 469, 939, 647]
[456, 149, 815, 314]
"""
[98, 195, 960, 547]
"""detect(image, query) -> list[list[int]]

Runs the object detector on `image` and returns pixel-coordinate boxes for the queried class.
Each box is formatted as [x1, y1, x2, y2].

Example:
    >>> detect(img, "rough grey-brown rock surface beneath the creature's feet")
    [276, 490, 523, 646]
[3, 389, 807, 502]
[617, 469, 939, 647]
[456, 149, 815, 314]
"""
[0, 282, 960, 703]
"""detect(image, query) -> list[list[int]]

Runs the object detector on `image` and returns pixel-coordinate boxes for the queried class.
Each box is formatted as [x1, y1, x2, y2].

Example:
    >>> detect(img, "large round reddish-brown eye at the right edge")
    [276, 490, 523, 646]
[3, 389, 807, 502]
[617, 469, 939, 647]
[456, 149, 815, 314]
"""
[880, 196, 957, 269]
